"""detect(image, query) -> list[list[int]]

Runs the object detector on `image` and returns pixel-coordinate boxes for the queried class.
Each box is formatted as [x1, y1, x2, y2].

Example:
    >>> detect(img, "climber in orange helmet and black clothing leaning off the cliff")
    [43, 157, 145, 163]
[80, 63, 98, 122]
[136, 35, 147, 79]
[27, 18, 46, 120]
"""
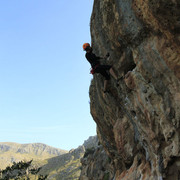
[83, 43, 119, 93]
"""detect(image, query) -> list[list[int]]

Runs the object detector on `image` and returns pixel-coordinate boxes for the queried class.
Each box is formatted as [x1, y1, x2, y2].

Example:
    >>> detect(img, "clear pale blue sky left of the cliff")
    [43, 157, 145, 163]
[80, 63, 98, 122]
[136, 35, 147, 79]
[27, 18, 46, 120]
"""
[0, 0, 96, 150]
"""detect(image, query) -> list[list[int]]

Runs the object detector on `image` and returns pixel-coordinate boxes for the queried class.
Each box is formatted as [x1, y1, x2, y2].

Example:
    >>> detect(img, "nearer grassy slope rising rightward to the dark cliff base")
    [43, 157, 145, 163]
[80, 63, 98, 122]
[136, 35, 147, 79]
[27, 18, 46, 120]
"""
[39, 136, 99, 180]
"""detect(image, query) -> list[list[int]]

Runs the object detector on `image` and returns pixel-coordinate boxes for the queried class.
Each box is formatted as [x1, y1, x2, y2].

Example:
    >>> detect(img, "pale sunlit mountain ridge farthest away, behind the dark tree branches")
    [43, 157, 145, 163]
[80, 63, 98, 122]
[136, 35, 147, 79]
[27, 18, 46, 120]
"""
[0, 142, 68, 169]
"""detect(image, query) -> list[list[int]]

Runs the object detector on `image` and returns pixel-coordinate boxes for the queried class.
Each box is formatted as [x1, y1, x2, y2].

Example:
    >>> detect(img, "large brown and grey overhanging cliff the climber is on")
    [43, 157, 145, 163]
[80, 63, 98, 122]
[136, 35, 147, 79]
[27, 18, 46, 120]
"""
[81, 0, 180, 180]
